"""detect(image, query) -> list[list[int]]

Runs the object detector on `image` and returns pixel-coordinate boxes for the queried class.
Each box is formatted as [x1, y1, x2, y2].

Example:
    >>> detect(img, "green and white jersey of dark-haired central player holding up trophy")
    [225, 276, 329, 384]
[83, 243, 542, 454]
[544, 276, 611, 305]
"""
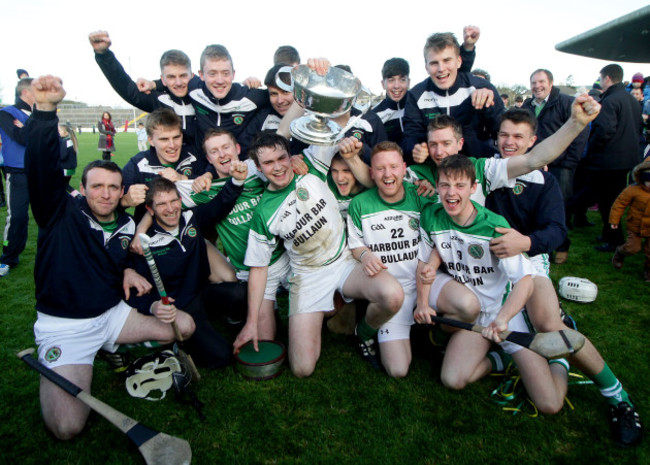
[244, 146, 347, 273]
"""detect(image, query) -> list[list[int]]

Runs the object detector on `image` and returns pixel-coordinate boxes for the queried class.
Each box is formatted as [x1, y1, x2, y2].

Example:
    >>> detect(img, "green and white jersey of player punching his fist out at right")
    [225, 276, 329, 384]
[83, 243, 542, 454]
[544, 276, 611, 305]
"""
[405, 157, 515, 205]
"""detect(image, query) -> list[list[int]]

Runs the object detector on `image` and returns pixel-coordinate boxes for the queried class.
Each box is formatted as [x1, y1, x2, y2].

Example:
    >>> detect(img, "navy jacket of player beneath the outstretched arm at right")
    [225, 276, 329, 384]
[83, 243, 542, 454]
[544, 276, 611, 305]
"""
[485, 167, 567, 257]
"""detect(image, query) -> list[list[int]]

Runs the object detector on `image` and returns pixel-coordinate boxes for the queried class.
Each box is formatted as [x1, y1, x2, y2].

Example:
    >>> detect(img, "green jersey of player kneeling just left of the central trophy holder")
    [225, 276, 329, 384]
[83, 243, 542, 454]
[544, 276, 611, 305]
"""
[176, 159, 283, 270]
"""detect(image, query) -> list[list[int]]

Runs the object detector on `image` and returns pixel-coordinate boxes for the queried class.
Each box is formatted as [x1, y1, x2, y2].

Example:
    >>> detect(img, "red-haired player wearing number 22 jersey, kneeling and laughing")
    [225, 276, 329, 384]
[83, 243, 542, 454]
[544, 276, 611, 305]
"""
[347, 141, 436, 378]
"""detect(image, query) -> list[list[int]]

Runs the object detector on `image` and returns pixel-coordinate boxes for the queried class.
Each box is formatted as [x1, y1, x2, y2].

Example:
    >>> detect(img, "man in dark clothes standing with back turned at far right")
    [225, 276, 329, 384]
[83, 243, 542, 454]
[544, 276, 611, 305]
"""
[576, 64, 642, 252]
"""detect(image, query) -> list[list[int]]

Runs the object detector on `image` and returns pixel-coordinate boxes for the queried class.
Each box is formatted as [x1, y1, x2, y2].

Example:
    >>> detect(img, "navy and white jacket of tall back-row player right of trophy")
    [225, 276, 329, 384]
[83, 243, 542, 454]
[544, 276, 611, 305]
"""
[402, 71, 505, 158]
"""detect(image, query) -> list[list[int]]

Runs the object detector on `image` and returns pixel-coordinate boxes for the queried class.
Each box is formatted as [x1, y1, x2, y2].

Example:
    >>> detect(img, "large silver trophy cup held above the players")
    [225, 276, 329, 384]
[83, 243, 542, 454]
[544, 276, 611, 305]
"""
[291, 65, 362, 145]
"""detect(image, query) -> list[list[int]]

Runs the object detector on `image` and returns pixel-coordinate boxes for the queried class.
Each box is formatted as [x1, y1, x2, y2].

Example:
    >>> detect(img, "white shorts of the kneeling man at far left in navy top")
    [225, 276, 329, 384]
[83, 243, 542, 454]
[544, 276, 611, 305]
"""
[34, 300, 131, 368]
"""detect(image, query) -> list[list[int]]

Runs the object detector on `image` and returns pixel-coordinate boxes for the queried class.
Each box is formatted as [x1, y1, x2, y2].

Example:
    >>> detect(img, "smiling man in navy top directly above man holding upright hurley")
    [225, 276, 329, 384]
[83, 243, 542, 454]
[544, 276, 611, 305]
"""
[121, 108, 205, 221]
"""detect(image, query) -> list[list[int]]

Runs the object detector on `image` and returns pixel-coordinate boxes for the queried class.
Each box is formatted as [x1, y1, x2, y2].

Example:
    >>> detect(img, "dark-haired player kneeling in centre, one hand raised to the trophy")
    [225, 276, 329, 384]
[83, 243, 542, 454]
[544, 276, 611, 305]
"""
[235, 129, 404, 377]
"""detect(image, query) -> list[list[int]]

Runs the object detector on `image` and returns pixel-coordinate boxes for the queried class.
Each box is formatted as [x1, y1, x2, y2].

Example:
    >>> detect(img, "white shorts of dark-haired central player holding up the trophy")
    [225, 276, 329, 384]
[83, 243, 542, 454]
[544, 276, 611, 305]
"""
[289, 251, 359, 316]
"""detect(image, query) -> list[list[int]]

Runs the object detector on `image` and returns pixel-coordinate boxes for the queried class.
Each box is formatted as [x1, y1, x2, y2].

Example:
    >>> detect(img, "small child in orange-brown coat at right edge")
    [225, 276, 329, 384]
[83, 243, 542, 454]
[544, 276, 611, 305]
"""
[609, 159, 650, 282]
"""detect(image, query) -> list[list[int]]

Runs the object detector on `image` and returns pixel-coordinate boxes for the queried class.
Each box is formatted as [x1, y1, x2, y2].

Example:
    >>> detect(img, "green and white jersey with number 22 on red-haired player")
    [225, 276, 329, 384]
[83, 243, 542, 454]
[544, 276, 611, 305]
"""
[347, 183, 431, 292]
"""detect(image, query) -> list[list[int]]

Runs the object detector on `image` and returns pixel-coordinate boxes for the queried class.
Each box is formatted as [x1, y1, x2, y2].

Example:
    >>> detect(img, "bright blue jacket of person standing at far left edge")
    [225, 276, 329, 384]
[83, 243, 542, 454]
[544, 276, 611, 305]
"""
[0, 99, 32, 172]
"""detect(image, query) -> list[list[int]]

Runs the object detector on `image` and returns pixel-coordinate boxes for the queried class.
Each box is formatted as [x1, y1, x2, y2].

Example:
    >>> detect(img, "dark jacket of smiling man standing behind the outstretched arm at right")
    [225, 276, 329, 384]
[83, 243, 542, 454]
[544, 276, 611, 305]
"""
[521, 87, 589, 169]
